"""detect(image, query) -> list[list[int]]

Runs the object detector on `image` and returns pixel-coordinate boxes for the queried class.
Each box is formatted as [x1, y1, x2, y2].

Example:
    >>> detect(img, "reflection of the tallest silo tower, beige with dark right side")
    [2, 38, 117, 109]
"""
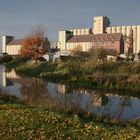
[91, 92, 108, 106]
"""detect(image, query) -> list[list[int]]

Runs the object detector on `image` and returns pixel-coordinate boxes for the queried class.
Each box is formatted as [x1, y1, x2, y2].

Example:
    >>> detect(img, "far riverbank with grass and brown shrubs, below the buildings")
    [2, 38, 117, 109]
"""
[16, 60, 140, 92]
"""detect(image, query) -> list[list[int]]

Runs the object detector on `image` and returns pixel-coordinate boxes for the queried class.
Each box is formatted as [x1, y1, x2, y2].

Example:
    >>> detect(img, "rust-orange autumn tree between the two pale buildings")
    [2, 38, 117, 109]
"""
[20, 27, 50, 63]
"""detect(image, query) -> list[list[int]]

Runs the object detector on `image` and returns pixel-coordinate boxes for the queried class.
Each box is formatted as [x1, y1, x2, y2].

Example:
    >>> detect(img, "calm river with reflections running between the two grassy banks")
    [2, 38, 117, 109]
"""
[0, 66, 140, 120]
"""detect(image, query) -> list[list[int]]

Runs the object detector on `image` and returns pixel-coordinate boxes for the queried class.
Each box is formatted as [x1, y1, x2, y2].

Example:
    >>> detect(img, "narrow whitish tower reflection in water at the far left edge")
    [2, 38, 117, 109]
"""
[0, 66, 6, 87]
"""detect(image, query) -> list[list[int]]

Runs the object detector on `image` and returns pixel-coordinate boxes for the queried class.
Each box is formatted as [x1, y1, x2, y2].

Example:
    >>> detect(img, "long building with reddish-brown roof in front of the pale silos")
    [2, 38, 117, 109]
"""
[66, 33, 123, 54]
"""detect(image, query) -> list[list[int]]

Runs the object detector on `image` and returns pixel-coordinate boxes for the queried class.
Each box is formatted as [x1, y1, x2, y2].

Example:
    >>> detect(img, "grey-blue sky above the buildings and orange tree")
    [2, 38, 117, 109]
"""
[0, 0, 140, 46]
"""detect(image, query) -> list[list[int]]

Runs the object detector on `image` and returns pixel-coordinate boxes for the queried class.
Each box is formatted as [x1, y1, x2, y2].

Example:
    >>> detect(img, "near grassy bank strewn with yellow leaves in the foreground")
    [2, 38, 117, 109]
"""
[0, 94, 140, 140]
